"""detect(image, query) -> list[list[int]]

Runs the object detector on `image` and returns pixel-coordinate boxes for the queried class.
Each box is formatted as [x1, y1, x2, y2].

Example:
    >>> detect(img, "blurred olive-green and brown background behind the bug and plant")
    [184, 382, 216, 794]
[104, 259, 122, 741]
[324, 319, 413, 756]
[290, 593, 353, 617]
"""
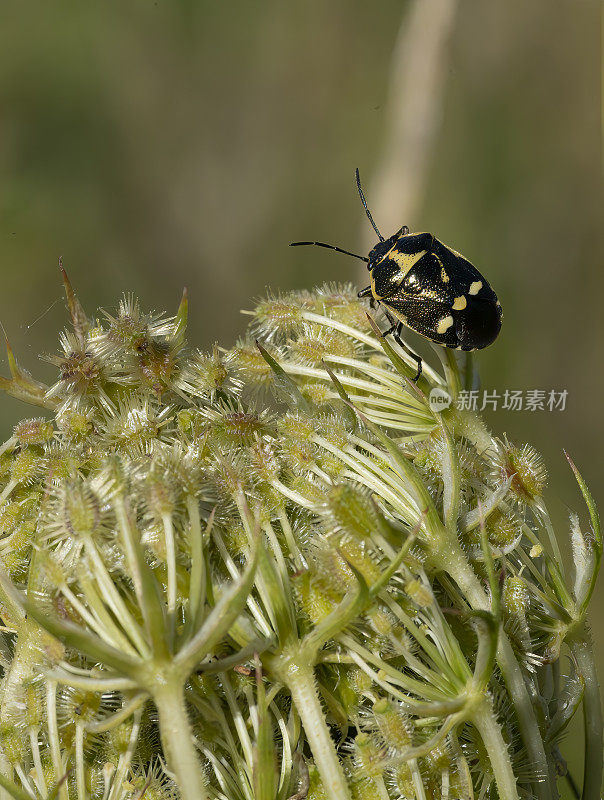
[0, 0, 604, 788]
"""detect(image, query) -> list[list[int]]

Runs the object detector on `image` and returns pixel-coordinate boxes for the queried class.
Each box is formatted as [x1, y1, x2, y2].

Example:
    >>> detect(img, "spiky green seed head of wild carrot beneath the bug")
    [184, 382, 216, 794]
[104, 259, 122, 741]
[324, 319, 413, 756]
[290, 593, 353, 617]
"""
[0, 272, 601, 800]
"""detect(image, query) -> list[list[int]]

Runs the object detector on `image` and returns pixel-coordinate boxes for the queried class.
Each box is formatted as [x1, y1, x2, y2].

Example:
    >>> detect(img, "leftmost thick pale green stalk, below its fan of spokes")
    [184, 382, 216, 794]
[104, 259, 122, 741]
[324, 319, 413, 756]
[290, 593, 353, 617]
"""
[153, 682, 208, 800]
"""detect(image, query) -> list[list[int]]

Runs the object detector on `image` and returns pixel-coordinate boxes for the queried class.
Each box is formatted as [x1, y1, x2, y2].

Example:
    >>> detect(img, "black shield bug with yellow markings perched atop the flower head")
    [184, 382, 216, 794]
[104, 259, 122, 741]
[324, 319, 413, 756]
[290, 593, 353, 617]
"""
[292, 169, 502, 380]
